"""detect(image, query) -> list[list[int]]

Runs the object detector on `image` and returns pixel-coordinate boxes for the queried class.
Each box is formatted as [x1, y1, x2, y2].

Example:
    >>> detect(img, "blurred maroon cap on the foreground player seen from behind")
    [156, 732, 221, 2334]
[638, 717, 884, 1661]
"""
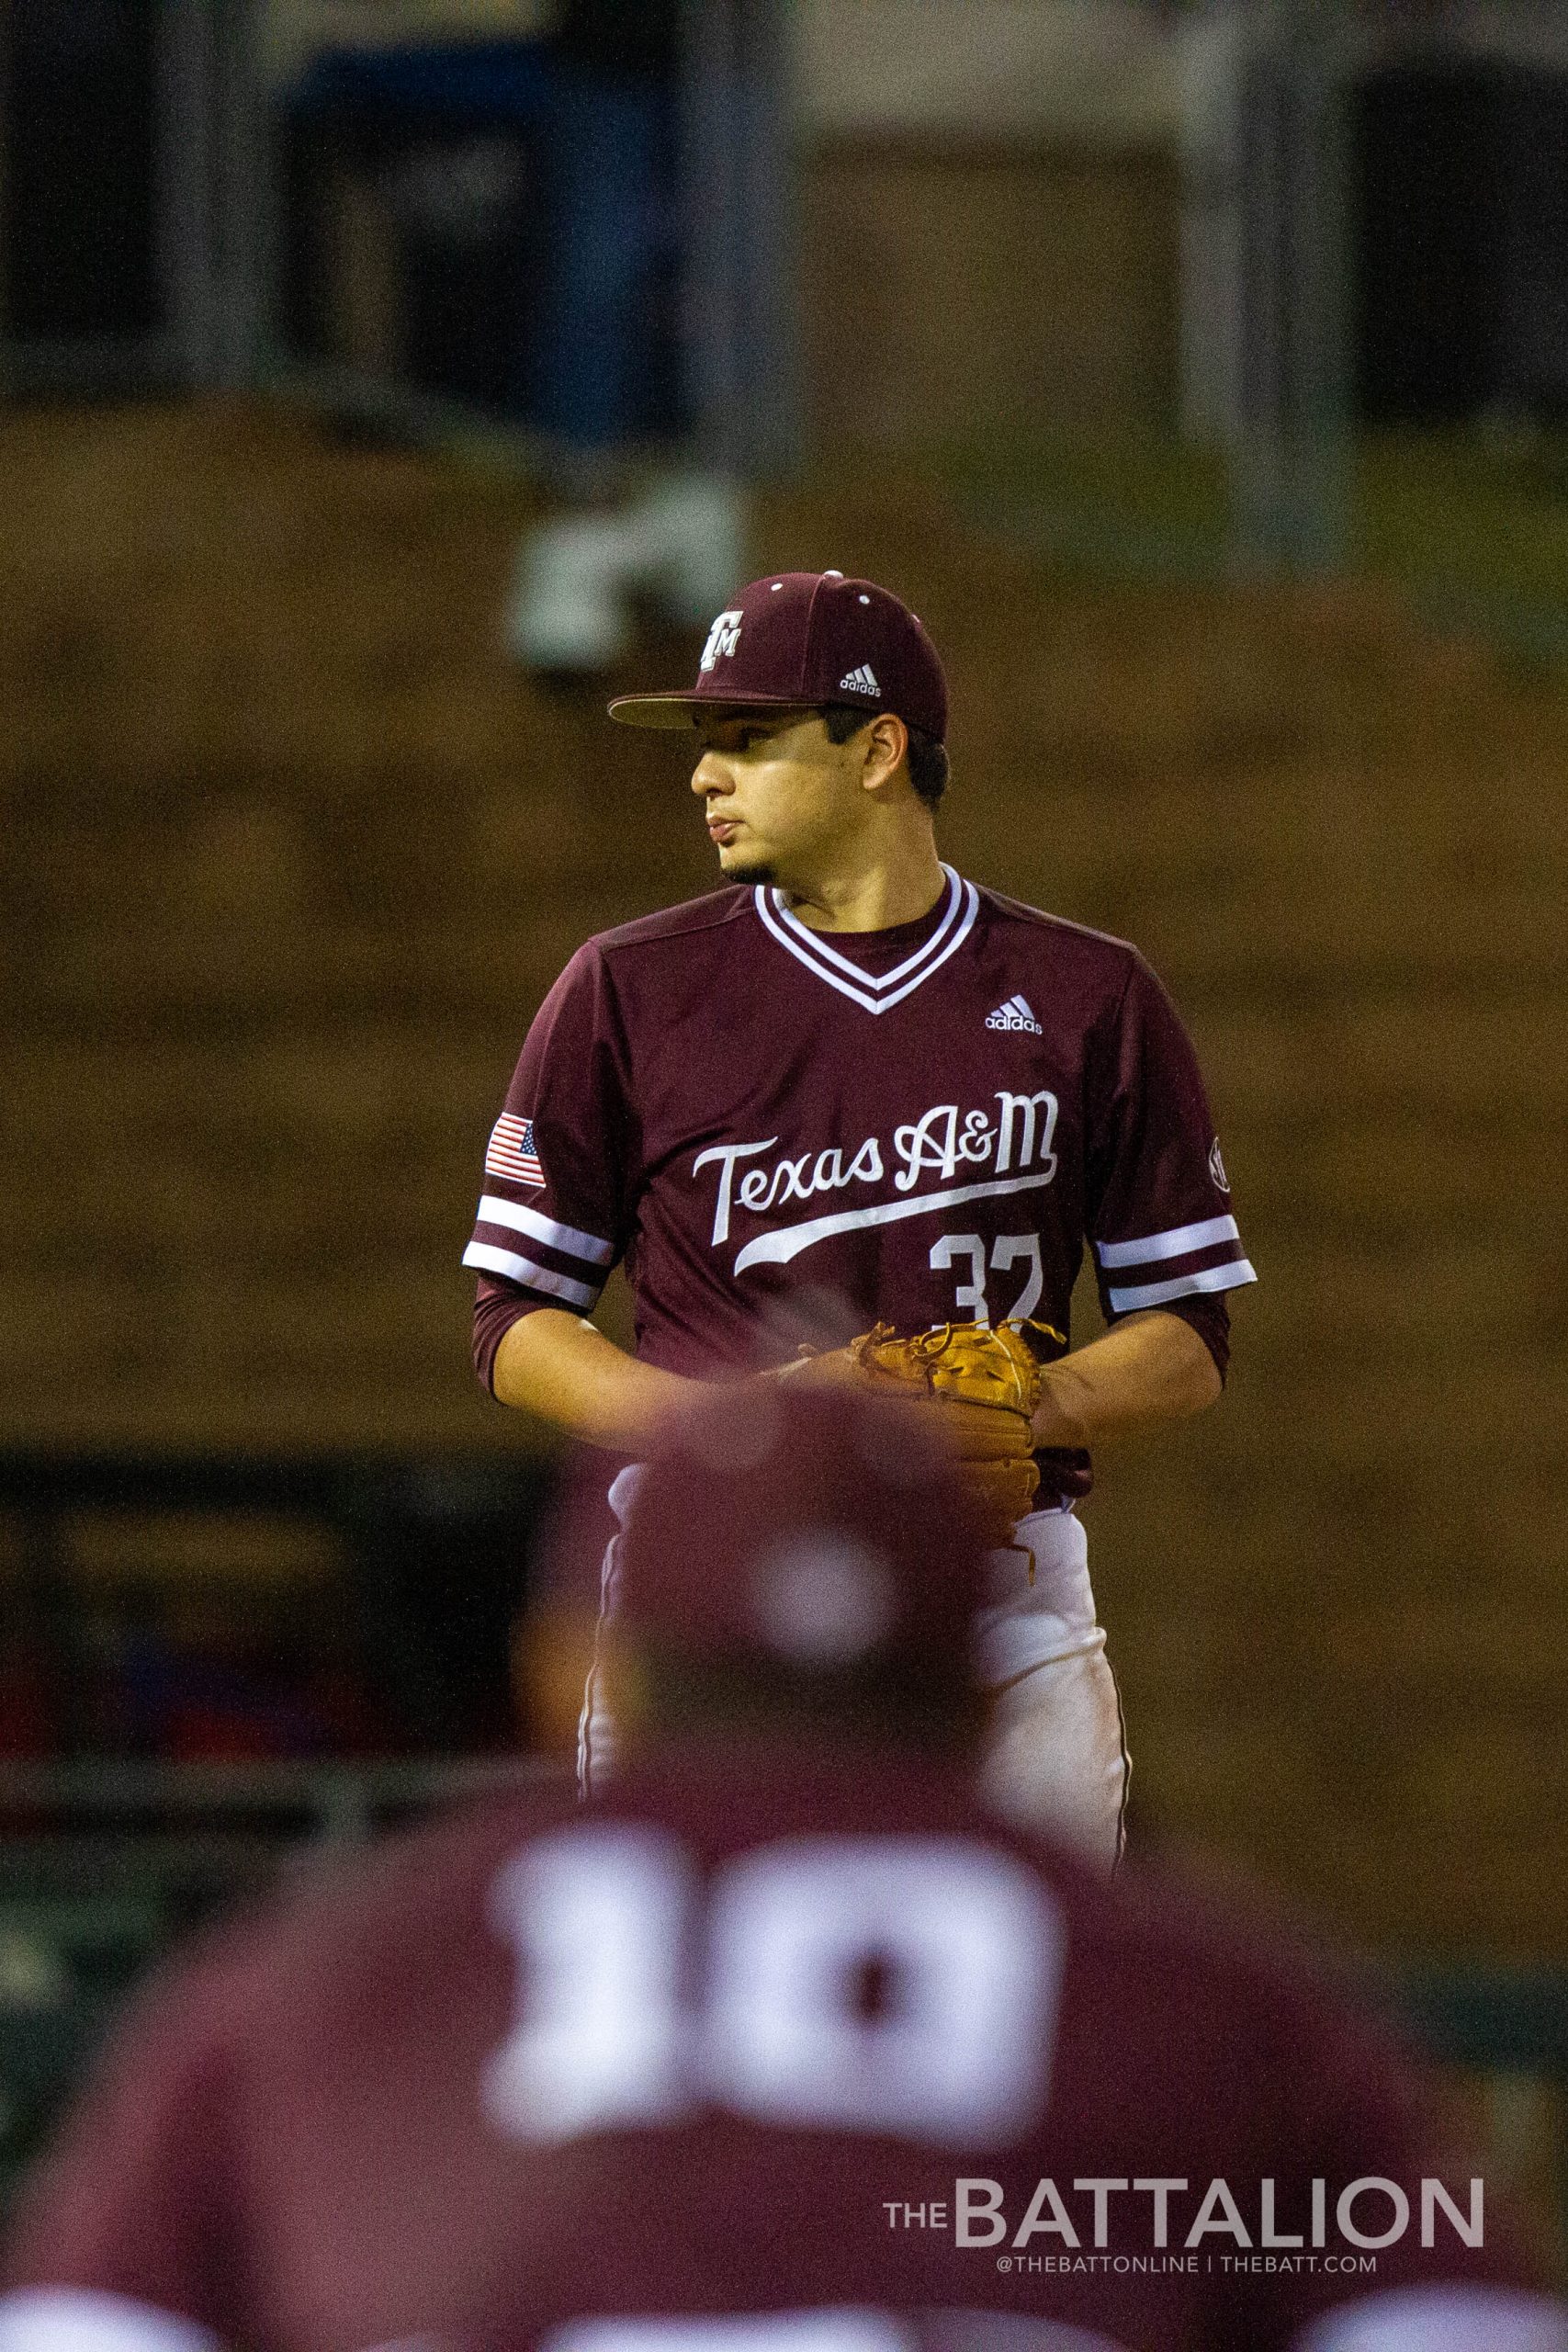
[616, 1378, 987, 1689]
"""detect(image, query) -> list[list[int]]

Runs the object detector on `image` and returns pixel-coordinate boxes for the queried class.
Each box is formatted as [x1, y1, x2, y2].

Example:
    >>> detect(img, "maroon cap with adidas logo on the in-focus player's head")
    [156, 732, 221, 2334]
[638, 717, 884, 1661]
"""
[609, 571, 947, 743]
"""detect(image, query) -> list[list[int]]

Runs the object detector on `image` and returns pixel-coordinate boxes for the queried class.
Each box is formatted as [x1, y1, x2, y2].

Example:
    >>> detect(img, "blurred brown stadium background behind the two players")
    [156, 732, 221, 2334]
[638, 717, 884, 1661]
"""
[0, 0, 1568, 2277]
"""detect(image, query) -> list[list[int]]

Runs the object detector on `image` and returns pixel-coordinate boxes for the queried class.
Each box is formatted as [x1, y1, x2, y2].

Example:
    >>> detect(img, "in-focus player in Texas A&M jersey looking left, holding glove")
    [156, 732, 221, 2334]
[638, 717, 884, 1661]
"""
[466, 571, 1253, 1860]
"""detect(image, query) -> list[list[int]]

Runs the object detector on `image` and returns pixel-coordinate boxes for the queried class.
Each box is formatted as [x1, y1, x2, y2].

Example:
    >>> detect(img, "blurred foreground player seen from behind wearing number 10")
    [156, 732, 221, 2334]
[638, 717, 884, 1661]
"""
[0, 1383, 1568, 2352]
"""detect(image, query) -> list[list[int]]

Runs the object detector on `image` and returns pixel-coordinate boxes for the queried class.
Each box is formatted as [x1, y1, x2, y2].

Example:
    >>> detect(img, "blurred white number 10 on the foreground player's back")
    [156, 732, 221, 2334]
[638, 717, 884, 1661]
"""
[484, 1826, 1063, 2147]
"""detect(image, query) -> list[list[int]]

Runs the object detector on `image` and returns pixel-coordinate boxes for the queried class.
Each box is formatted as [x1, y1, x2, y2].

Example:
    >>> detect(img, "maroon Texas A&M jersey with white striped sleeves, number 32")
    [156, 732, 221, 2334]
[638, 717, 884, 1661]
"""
[466, 868, 1253, 1376]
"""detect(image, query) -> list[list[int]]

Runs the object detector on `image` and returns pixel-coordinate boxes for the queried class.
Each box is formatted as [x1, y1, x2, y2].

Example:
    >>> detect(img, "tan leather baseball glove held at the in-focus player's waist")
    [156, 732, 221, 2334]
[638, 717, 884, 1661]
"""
[783, 1322, 1065, 1545]
